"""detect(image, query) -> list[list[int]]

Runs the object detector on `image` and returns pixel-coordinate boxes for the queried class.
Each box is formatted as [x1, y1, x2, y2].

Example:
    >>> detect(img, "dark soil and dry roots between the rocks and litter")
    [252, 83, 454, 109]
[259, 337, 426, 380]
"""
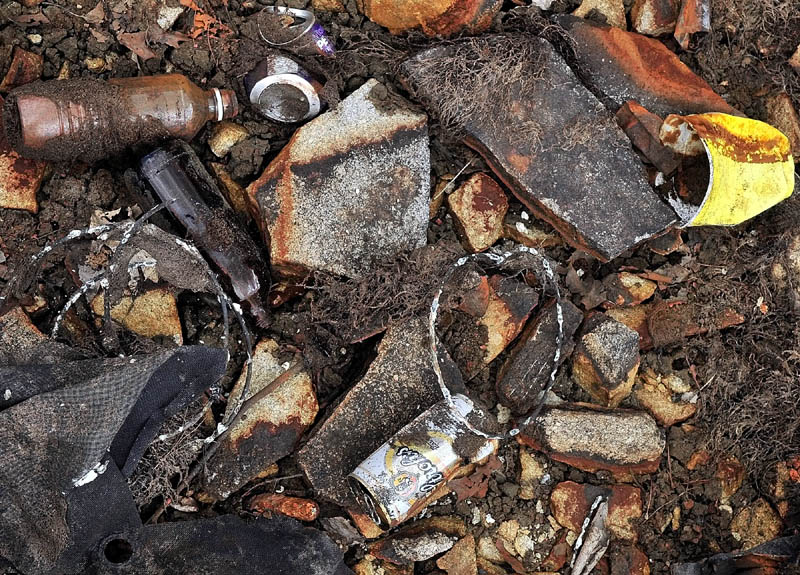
[0, 0, 800, 575]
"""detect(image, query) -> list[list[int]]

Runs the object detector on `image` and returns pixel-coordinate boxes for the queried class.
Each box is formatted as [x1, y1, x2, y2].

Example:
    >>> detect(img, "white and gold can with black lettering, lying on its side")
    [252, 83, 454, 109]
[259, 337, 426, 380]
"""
[348, 394, 498, 528]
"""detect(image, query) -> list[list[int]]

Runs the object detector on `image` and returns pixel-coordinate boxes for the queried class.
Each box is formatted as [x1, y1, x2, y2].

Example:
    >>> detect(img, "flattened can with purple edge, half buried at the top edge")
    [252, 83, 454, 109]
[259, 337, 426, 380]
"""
[256, 6, 336, 56]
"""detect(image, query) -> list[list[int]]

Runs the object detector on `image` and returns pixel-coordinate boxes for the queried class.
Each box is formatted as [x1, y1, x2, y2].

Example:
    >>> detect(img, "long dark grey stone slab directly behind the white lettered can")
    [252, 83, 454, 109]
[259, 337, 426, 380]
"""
[297, 318, 455, 507]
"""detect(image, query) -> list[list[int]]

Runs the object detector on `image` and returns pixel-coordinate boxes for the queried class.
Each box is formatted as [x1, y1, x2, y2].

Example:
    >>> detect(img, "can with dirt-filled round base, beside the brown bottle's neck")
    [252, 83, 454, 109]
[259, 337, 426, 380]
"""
[244, 54, 322, 124]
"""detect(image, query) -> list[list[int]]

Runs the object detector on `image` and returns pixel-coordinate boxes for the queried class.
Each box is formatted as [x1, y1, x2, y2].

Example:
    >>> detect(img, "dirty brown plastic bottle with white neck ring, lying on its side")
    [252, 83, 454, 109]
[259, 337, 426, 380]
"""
[3, 74, 238, 163]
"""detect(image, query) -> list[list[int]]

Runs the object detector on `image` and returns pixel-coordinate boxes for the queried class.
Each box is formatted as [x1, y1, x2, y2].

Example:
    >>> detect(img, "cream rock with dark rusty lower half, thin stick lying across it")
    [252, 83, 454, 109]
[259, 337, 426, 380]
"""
[205, 339, 319, 499]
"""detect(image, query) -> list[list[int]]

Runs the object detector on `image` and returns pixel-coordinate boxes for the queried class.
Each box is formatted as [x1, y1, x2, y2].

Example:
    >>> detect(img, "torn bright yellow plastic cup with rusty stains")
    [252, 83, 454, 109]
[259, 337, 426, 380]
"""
[660, 113, 794, 227]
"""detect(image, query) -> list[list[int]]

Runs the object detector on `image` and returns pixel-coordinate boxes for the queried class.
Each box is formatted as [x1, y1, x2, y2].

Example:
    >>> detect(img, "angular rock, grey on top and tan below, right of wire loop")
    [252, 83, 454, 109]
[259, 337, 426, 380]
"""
[572, 314, 639, 407]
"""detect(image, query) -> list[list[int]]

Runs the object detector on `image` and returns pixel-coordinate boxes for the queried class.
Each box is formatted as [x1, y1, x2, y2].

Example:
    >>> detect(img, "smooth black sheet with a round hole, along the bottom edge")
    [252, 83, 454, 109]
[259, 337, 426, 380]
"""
[87, 515, 352, 575]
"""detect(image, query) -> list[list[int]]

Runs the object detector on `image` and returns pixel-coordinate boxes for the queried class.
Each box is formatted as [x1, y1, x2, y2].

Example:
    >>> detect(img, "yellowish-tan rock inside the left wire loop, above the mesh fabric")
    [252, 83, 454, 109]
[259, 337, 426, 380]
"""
[91, 288, 183, 345]
